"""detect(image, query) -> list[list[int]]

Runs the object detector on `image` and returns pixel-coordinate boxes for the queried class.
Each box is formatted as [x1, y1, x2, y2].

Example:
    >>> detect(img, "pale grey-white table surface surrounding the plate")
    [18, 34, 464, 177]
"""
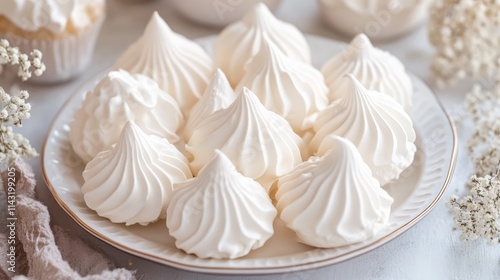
[13, 0, 500, 280]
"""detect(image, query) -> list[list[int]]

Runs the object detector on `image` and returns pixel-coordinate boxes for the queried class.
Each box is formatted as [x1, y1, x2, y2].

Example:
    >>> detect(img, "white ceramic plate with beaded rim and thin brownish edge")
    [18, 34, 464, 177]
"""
[42, 36, 457, 274]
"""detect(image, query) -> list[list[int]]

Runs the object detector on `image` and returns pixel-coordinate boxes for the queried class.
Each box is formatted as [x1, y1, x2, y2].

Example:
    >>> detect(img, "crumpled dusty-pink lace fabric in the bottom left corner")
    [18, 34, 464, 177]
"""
[0, 159, 135, 280]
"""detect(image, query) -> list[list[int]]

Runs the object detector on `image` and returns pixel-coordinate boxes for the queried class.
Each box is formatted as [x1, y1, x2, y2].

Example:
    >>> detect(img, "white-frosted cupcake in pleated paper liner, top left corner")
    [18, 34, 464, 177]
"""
[0, 0, 105, 83]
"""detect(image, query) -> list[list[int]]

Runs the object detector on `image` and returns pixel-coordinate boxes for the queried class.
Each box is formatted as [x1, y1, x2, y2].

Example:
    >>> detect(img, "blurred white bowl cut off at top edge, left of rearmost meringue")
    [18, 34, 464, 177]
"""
[171, 0, 281, 27]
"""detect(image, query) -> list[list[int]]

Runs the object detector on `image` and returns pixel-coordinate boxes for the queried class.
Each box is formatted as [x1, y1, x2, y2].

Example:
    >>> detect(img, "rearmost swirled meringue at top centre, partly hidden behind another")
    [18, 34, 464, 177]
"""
[214, 3, 311, 86]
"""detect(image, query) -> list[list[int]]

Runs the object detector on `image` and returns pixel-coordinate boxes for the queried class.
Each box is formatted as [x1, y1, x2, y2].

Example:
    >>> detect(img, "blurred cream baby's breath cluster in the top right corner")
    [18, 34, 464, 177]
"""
[429, 0, 500, 85]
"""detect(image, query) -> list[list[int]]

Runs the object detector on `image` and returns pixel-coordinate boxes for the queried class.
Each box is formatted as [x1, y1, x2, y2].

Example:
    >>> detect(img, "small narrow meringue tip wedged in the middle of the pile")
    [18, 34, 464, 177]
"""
[184, 69, 236, 141]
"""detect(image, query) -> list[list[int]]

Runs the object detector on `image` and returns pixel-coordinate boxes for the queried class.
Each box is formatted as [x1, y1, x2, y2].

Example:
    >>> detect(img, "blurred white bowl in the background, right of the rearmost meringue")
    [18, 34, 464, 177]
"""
[317, 0, 433, 40]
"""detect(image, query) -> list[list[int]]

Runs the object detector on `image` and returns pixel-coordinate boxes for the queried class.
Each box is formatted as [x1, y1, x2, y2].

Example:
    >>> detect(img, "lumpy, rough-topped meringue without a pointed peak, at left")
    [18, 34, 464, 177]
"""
[69, 70, 184, 162]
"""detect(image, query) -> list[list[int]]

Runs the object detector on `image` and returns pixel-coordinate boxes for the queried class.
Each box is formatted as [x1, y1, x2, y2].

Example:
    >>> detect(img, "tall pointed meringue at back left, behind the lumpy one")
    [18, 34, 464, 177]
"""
[113, 12, 214, 116]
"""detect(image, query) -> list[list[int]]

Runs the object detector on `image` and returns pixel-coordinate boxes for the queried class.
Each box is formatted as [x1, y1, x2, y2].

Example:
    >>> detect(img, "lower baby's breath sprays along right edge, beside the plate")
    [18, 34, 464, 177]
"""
[446, 79, 500, 244]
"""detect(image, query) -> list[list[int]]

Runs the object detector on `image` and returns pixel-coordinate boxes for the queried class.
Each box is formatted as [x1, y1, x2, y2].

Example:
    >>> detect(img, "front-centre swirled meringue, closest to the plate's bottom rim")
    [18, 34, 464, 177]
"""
[167, 150, 277, 259]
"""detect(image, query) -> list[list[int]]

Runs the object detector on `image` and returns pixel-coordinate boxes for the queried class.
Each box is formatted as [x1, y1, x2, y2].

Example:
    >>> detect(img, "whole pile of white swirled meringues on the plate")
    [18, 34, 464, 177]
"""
[69, 4, 416, 259]
